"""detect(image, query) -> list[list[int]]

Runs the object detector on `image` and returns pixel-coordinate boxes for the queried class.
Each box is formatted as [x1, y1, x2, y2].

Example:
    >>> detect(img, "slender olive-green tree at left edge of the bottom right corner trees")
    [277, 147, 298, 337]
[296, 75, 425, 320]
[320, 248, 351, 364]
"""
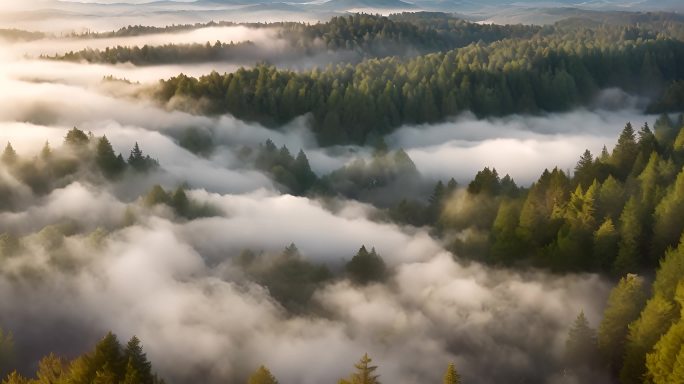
[598, 275, 646, 372]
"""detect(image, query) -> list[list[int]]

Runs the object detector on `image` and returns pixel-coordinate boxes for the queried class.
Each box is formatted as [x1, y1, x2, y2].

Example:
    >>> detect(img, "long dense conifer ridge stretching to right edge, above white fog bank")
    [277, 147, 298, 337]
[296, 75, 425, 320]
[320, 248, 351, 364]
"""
[156, 30, 684, 144]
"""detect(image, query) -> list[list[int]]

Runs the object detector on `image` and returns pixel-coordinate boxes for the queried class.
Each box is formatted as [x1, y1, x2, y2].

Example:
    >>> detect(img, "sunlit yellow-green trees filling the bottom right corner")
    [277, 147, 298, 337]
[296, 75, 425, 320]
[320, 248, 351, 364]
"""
[598, 237, 684, 384]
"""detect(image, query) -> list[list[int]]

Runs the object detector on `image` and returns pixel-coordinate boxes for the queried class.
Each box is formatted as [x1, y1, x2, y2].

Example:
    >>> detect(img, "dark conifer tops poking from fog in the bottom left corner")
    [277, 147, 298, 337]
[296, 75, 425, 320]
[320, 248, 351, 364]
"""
[0, 332, 164, 384]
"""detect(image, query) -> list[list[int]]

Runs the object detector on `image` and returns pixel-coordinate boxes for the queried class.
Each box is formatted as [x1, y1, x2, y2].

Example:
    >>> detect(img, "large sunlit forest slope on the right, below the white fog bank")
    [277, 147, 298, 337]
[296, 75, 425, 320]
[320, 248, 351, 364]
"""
[438, 115, 684, 276]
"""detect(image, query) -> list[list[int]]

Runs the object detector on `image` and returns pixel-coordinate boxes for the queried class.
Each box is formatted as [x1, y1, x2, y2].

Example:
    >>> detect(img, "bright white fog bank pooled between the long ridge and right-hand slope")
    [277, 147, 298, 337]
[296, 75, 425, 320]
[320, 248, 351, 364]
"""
[387, 107, 657, 185]
